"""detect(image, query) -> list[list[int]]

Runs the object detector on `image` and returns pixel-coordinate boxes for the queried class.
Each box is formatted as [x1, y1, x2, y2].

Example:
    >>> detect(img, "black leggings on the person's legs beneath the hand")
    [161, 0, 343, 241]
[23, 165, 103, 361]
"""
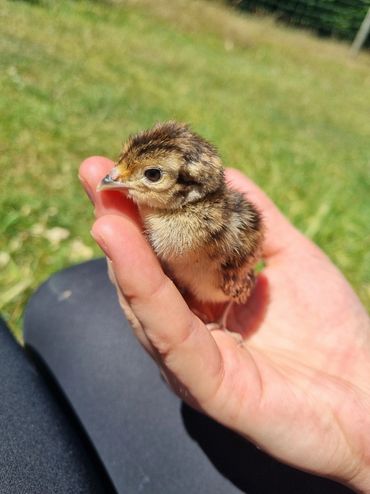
[0, 259, 350, 494]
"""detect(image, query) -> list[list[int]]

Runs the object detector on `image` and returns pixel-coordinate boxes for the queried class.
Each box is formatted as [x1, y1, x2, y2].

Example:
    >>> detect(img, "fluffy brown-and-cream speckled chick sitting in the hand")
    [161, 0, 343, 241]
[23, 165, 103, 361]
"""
[99, 122, 263, 325]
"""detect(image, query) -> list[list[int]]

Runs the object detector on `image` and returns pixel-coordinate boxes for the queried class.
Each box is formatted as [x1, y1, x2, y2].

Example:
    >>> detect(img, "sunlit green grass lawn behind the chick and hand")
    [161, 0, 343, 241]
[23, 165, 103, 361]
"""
[0, 0, 370, 336]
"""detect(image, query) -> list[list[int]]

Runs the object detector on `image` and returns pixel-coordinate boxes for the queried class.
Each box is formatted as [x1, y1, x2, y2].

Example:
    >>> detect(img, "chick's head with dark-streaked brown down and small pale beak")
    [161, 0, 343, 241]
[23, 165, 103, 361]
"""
[100, 122, 225, 209]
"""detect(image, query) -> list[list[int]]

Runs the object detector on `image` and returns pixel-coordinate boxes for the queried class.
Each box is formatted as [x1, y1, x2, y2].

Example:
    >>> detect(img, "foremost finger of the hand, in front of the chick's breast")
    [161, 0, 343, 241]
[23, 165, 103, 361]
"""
[93, 215, 223, 402]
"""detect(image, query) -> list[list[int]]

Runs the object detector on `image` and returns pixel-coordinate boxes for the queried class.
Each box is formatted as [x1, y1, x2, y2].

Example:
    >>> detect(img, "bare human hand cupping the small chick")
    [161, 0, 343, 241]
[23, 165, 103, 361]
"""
[80, 158, 370, 493]
